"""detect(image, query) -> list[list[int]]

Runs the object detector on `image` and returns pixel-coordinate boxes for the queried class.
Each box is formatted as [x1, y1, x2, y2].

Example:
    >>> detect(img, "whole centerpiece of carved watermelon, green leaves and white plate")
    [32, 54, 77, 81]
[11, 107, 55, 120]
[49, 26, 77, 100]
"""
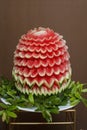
[0, 27, 87, 123]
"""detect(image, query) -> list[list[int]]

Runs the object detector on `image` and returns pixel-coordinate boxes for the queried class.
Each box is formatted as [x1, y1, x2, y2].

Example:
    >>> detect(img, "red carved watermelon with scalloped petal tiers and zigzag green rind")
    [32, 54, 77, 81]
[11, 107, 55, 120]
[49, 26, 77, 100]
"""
[12, 27, 71, 95]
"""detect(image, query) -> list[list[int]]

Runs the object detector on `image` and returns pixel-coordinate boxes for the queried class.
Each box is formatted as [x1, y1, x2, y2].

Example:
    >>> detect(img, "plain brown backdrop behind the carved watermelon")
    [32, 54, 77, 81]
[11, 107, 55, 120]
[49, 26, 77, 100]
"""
[0, 0, 87, 130]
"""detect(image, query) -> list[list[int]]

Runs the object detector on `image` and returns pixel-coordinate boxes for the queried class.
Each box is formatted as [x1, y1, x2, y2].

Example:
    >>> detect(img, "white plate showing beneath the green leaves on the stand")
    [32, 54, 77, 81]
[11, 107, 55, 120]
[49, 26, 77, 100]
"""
[1, 98, 74, 112]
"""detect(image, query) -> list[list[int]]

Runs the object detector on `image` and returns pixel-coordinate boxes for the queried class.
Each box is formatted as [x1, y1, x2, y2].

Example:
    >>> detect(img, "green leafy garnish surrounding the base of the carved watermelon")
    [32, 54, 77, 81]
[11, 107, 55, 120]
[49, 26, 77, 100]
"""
[0, 78, 87, 123]
